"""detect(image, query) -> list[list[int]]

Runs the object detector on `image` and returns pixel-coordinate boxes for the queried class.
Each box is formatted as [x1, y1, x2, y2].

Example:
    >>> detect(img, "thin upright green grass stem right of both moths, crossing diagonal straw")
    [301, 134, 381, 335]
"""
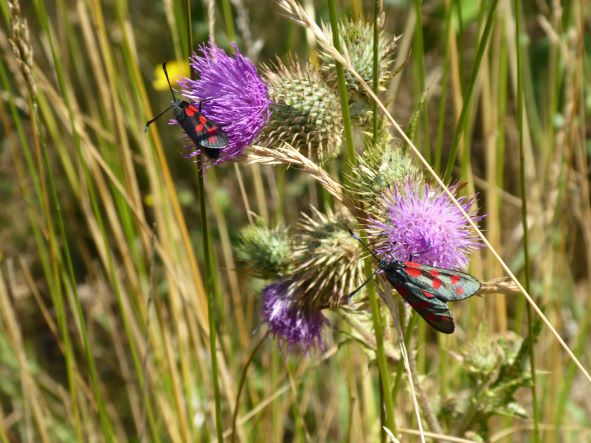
[515, 0, 540, 443]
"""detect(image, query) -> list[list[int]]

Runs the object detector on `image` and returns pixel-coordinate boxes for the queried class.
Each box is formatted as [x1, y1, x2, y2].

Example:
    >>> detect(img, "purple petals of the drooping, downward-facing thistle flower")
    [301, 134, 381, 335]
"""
[262, 280, 328, 353]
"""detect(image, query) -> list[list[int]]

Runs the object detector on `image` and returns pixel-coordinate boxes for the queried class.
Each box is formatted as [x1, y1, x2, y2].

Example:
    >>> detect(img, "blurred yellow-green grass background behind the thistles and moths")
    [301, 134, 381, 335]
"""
[0, 0, 591, 442]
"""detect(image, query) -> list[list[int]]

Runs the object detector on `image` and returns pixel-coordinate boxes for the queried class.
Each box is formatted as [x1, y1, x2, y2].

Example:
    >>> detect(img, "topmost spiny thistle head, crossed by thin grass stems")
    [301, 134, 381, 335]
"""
[320, 20, 397, 95]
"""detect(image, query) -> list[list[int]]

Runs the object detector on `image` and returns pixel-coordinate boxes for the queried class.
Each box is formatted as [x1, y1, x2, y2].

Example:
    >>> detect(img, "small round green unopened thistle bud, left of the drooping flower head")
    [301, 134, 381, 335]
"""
[236, 220, 292, 279]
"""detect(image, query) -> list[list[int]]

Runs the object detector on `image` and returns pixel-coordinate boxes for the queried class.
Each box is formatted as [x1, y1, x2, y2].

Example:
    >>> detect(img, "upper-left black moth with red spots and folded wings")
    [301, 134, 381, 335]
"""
[144, 62, 228, 160]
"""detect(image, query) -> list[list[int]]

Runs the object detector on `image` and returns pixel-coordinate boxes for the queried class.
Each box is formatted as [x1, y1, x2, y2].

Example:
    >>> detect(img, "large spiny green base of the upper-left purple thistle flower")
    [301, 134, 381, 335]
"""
[261, 60, 343, 162]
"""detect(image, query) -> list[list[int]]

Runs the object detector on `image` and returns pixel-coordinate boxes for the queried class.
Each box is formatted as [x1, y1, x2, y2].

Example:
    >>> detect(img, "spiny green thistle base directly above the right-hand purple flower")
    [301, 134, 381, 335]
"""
[347, 130, 423, 213]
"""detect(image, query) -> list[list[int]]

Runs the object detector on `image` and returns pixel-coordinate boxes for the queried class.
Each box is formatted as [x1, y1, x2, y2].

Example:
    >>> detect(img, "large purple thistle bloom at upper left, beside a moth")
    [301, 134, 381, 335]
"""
[178, 41, 271, 164]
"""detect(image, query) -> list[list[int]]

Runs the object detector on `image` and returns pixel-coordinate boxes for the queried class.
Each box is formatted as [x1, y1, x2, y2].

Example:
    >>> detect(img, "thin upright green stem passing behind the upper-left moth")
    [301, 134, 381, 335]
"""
[184, 0, 224, 442]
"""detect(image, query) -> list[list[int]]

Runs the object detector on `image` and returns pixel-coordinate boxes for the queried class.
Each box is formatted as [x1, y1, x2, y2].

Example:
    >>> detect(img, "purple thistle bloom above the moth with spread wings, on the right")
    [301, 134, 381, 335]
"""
[369, 182, 482, 269]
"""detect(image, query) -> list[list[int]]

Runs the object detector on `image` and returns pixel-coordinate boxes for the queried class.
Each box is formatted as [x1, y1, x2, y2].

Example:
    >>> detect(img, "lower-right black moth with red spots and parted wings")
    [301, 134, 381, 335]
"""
[349, 230, 480, 334]
